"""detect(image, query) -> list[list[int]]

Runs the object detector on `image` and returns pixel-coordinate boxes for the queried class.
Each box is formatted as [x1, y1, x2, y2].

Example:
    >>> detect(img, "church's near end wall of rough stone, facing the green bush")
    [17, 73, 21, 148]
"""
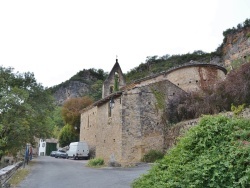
[119, 80, 186, 166]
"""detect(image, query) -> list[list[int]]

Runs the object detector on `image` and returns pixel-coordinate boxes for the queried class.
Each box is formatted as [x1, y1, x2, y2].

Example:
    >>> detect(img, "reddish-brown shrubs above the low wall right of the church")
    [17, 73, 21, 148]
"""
[167, 62, 250, 123]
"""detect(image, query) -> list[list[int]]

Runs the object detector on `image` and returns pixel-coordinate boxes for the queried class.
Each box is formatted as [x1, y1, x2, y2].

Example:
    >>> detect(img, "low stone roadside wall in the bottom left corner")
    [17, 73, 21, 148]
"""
[0, 161, 23, 188]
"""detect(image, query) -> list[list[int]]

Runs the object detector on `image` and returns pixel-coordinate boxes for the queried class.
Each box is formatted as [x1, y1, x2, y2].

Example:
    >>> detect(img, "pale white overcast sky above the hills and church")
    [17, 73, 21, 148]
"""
[0, 0, 250, 87]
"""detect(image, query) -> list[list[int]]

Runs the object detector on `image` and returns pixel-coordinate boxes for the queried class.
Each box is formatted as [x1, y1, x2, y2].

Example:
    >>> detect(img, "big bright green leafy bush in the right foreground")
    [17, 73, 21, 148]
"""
[133, 116, 250, 188]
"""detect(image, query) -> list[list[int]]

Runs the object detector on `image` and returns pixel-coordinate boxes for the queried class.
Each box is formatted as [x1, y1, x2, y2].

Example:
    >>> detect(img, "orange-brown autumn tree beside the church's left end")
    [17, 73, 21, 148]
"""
[62, 96, 93, 130]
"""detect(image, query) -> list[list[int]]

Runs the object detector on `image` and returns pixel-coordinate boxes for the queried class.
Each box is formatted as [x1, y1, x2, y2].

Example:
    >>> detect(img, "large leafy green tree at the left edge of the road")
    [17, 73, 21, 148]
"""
[0, 67, 54, 156]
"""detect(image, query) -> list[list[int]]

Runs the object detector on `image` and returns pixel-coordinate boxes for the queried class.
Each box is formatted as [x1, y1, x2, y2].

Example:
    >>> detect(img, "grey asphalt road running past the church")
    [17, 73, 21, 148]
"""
[18, 157, 150, 188]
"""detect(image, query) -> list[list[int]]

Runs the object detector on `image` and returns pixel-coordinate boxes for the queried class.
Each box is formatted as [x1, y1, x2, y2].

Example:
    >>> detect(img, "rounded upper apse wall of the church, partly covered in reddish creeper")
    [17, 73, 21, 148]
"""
[133, 61, 226, 92]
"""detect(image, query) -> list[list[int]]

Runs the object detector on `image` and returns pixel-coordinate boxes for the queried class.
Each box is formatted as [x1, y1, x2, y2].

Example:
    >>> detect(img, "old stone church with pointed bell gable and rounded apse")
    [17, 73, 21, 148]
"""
[80, 59, 227, 166]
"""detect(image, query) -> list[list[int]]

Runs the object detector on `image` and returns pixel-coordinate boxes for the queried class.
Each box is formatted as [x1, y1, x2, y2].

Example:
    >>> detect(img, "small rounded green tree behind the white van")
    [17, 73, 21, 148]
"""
[59, 124, 79, 147]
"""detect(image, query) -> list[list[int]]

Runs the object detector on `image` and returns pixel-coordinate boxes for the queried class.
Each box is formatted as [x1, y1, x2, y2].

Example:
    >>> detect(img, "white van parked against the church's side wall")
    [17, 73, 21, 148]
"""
[67, 142, 89, 159]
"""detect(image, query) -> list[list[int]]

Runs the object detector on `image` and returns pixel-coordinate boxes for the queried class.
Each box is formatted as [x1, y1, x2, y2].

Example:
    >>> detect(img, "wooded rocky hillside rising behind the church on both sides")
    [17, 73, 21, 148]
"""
[50, 19, 250, 105]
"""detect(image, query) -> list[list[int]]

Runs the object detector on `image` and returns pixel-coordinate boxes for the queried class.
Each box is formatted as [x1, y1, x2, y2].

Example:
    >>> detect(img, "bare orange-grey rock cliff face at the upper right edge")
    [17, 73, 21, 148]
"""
[222, 27, 250, 69]
